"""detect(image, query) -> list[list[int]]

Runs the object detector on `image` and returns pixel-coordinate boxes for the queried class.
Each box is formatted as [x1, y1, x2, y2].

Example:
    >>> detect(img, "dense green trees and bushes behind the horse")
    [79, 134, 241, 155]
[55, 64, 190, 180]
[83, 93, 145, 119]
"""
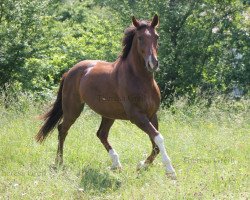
[0, 0, 250, 103]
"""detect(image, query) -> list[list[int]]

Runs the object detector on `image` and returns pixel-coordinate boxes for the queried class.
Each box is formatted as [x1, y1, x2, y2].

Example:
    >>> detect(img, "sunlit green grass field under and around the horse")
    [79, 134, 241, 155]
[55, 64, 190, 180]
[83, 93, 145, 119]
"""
[0, 96, 250, 200]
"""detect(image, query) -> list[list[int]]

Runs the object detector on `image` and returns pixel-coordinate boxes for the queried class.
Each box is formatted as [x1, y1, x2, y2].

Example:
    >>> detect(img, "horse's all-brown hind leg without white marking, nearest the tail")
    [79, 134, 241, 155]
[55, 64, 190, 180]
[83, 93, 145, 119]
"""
[55, 101, 84, 165]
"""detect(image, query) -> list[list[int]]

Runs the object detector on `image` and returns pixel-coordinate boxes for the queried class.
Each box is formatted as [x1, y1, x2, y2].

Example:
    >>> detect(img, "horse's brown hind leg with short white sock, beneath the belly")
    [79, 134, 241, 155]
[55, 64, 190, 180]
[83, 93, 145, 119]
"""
[97, 117, 122, 170]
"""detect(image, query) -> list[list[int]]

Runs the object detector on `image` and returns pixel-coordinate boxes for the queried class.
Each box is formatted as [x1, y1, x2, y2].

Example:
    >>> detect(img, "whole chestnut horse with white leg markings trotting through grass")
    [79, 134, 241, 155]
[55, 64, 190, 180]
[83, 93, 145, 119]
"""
[36, 15, 176, 179]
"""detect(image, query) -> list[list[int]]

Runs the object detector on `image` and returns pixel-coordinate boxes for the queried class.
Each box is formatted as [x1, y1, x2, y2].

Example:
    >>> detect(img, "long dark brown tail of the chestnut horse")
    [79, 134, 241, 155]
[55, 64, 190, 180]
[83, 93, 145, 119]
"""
[35, 73, 67, 143]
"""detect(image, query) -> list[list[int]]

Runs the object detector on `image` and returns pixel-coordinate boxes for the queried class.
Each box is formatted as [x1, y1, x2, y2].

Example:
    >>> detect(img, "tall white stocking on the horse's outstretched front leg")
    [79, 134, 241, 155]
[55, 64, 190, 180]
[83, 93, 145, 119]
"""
[154, 134, 175, 177]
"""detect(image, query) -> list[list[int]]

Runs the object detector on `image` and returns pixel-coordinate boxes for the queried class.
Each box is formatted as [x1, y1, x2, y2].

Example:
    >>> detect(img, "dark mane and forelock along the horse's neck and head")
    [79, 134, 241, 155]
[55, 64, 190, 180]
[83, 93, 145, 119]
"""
[120, 20, 150, 60]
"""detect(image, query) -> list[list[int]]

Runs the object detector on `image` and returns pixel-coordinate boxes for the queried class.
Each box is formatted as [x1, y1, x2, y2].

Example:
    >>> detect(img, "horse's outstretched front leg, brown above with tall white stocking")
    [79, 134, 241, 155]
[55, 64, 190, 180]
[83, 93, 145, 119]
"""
[130, 109, 176, 179]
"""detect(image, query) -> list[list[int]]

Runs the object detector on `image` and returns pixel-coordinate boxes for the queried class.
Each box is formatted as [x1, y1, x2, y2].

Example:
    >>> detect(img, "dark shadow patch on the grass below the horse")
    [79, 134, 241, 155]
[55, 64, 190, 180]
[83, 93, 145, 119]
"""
[80, 167, 121, 193]
